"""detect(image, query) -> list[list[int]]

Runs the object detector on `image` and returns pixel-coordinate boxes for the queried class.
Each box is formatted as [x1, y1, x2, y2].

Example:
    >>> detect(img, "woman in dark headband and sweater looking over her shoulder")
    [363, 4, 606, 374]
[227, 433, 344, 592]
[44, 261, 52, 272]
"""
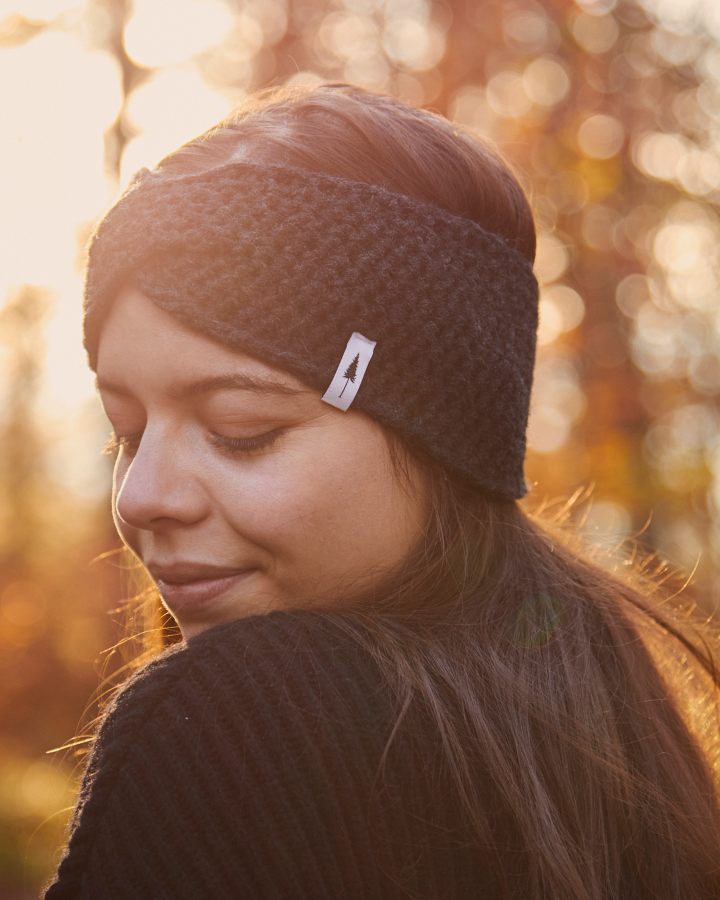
[45, 84, 720, 900]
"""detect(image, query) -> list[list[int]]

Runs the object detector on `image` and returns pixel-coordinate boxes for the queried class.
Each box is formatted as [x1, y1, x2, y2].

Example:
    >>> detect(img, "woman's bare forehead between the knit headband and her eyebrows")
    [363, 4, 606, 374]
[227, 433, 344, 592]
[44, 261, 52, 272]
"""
[96, 288, 319, 400]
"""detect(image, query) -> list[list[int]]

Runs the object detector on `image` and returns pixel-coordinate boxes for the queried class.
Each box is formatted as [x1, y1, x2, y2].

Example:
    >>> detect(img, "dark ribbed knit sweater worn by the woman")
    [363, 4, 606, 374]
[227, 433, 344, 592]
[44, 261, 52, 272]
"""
[44, 611, 510, 900]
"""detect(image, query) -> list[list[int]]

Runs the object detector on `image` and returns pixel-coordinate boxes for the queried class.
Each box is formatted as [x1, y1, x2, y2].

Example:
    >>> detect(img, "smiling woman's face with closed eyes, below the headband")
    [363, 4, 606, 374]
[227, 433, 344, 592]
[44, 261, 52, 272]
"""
[97, 289, 428, 638]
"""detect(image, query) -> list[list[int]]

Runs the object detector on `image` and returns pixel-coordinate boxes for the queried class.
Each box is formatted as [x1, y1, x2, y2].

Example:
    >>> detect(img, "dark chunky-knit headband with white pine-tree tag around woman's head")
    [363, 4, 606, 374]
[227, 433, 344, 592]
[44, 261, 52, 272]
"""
[84, 162, 538, 498]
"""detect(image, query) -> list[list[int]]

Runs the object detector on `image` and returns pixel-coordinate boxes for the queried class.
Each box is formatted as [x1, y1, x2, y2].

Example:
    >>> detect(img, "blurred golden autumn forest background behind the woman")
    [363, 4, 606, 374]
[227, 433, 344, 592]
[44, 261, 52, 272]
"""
[0, 0, 720, 900]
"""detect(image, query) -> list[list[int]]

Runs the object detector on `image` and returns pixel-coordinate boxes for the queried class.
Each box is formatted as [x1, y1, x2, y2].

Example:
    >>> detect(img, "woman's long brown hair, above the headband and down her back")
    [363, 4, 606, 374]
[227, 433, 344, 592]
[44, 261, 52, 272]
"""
[87, 83, 720, 900]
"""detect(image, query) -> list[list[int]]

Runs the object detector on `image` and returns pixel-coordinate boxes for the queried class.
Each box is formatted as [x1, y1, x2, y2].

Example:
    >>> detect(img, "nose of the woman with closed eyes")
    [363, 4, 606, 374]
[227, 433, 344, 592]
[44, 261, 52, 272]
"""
[113, 427, 207, 530]
